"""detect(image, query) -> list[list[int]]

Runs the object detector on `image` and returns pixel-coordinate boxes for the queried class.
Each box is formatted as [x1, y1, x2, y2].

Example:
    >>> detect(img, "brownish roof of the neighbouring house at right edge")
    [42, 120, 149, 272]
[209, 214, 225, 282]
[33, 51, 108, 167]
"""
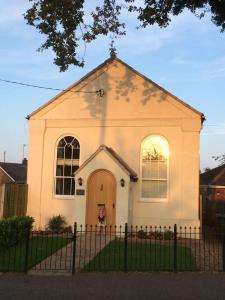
[200, 164, 225, 186]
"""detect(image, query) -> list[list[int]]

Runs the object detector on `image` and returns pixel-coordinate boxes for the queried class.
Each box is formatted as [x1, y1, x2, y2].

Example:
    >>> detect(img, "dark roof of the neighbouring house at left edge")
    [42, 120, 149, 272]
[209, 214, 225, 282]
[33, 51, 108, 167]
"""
[0, 162, 27, 183]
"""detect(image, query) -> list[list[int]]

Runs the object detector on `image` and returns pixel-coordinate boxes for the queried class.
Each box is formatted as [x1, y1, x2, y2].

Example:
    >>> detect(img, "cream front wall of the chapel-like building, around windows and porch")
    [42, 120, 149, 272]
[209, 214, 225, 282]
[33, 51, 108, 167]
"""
[28, 59, 201, 226]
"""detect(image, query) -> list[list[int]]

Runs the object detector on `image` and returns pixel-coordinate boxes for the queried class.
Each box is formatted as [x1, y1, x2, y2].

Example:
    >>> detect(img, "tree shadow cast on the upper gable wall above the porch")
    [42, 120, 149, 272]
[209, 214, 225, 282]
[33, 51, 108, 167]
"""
[81, 63, 168, 144]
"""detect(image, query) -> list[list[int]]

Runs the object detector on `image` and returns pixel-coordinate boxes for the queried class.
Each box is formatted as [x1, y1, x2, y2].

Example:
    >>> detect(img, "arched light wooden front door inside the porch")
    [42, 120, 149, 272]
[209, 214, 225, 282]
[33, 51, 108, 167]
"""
[86, 170, 116, 226]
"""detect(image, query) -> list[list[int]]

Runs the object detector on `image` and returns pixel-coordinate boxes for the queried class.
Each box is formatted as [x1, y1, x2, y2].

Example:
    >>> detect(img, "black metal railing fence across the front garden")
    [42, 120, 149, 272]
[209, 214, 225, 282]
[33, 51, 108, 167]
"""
[0, 224, 225, 274]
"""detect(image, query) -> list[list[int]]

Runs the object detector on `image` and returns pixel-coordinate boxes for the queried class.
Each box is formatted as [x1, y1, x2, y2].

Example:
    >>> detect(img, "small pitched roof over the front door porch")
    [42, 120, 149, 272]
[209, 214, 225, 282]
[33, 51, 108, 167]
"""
[74, 145, 138, 181]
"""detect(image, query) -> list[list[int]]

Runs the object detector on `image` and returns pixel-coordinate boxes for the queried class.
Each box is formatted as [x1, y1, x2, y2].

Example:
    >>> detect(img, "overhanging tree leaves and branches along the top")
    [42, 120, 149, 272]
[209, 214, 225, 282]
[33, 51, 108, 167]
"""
[24, 0, 225, 71]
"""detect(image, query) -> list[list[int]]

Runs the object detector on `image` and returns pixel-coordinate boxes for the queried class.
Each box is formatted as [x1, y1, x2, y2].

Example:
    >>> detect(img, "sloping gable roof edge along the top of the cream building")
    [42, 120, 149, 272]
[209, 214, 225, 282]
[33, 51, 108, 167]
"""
[27, 56, 205, 123]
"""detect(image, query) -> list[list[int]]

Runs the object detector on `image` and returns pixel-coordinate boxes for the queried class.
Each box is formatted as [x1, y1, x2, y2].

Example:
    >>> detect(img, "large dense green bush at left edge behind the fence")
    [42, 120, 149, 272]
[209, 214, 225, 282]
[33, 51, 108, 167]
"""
[0, 216, 34, 251]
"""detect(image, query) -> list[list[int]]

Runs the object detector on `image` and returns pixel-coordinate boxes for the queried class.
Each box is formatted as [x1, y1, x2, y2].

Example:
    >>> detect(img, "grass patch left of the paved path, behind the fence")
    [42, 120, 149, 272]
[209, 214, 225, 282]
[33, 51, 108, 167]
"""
[0, 236, 71, 272]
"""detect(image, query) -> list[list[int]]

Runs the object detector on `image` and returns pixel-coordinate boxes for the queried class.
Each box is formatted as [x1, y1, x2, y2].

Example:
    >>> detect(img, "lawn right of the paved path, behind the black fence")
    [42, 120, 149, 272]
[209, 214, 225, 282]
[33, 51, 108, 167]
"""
[83, 240, 195, 272]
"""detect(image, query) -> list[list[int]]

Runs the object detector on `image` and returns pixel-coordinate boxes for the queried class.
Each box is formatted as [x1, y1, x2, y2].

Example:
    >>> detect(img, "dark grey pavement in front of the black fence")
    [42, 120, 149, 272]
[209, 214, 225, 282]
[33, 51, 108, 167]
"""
[0, 272, 225, 300]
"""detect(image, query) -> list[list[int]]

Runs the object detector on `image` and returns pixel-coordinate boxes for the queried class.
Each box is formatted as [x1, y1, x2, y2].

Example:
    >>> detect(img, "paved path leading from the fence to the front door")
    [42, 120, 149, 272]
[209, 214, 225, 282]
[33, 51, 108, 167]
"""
[29, 233, 111, 274]
